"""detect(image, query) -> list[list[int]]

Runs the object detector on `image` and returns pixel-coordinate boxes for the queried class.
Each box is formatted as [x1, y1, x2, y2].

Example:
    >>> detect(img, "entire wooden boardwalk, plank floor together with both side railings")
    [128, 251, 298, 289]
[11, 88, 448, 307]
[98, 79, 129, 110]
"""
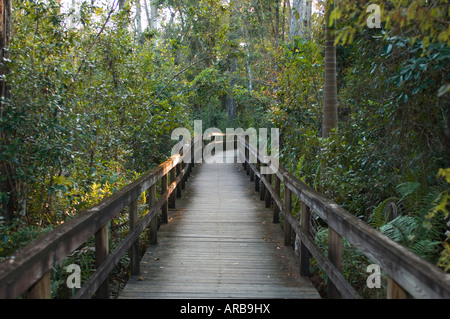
[0, 136, 450, 299]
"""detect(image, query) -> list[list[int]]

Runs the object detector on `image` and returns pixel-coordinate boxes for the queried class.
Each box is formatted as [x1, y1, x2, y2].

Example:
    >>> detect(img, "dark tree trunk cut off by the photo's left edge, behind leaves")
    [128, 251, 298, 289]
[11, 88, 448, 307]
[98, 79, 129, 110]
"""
[0, 0, 12, 221]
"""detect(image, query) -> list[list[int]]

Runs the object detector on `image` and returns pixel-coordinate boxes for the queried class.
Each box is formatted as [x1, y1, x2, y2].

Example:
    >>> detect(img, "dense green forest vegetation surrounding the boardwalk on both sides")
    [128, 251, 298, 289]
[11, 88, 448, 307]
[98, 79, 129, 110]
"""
[0, 0, 450, 300]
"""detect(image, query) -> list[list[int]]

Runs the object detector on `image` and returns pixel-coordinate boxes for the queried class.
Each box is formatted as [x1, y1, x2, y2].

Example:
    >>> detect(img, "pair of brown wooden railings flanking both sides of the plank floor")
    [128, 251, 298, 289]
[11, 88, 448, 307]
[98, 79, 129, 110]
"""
[0, 136, 450, 299]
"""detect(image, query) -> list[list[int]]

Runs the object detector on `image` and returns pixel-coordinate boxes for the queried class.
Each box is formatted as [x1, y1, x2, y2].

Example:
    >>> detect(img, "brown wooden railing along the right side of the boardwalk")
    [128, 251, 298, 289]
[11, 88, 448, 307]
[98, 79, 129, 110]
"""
[238, 136, 450, 299]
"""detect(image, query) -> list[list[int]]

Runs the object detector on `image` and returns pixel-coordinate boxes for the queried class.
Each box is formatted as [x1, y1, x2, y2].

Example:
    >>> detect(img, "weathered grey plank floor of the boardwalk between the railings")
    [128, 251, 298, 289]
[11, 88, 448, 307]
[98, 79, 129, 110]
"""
[120, 150, 319, 299]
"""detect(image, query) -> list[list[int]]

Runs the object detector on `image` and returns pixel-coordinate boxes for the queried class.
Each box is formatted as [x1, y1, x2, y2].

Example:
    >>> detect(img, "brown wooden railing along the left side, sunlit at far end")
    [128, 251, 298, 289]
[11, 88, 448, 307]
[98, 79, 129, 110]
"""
[0, 138, 202, 299]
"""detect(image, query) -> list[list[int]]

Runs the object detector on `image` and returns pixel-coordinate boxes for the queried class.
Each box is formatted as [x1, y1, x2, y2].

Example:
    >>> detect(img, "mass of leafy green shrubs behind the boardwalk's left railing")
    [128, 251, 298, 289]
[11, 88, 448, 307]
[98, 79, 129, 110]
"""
[0, 1, 189, 256]
